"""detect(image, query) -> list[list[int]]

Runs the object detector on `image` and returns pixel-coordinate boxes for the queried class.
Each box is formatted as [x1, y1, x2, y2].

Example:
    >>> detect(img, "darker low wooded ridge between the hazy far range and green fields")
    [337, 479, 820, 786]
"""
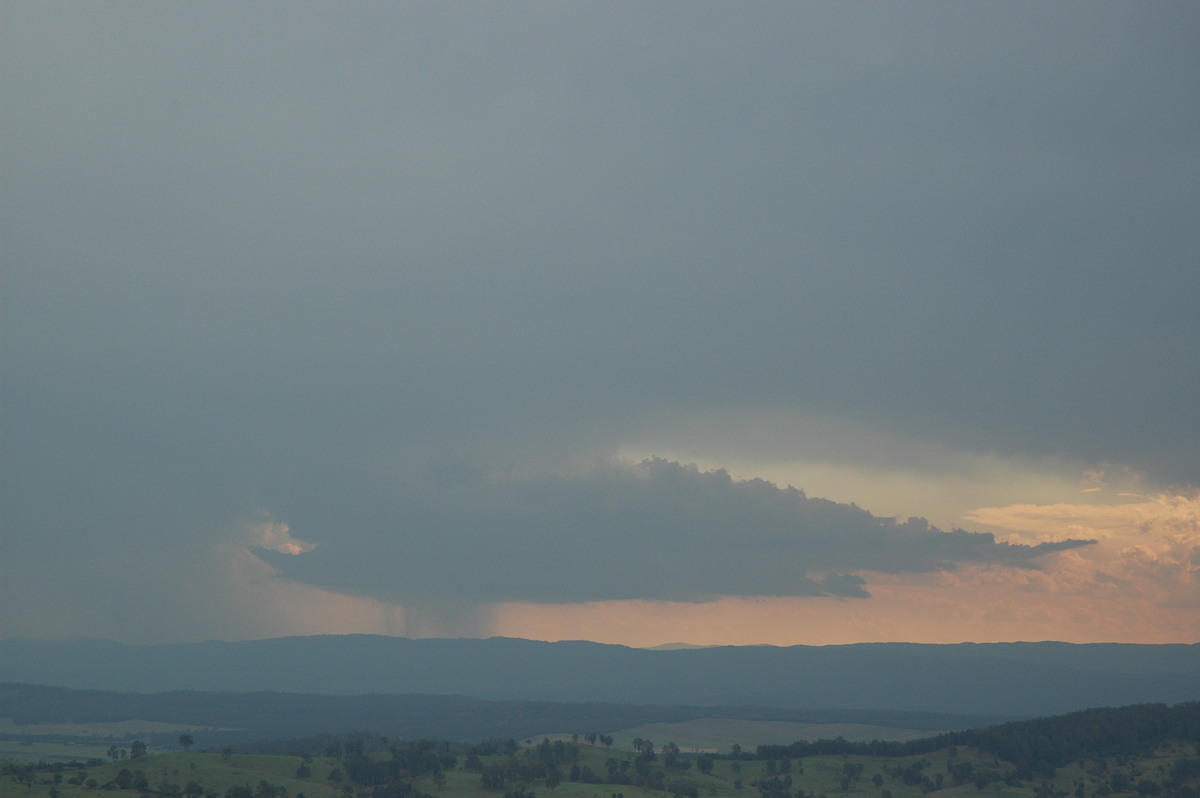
[0, 683, 1004, 750]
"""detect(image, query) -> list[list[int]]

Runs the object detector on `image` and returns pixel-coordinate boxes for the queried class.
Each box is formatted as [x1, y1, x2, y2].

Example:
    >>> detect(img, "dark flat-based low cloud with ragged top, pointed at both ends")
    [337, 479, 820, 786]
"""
[260, 460, 1094, 602]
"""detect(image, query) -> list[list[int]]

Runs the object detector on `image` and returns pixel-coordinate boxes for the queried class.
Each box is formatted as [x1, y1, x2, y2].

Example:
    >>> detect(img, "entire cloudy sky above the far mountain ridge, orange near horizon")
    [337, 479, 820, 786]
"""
[0, 0, 1200, 646]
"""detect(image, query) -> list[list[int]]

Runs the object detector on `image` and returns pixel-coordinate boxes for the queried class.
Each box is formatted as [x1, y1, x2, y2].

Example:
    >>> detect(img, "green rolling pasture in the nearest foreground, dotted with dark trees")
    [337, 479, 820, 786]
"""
[0, 743, 1198, 798]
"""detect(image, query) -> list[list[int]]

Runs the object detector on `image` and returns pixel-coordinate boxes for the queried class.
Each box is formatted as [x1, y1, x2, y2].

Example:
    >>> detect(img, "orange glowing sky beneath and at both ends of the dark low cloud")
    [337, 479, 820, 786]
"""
[216, 494, 1200, 646]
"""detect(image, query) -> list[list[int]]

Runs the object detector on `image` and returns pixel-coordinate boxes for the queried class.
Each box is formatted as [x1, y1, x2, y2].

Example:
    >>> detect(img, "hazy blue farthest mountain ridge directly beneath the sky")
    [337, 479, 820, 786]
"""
[0, 635, 1200, 718]
